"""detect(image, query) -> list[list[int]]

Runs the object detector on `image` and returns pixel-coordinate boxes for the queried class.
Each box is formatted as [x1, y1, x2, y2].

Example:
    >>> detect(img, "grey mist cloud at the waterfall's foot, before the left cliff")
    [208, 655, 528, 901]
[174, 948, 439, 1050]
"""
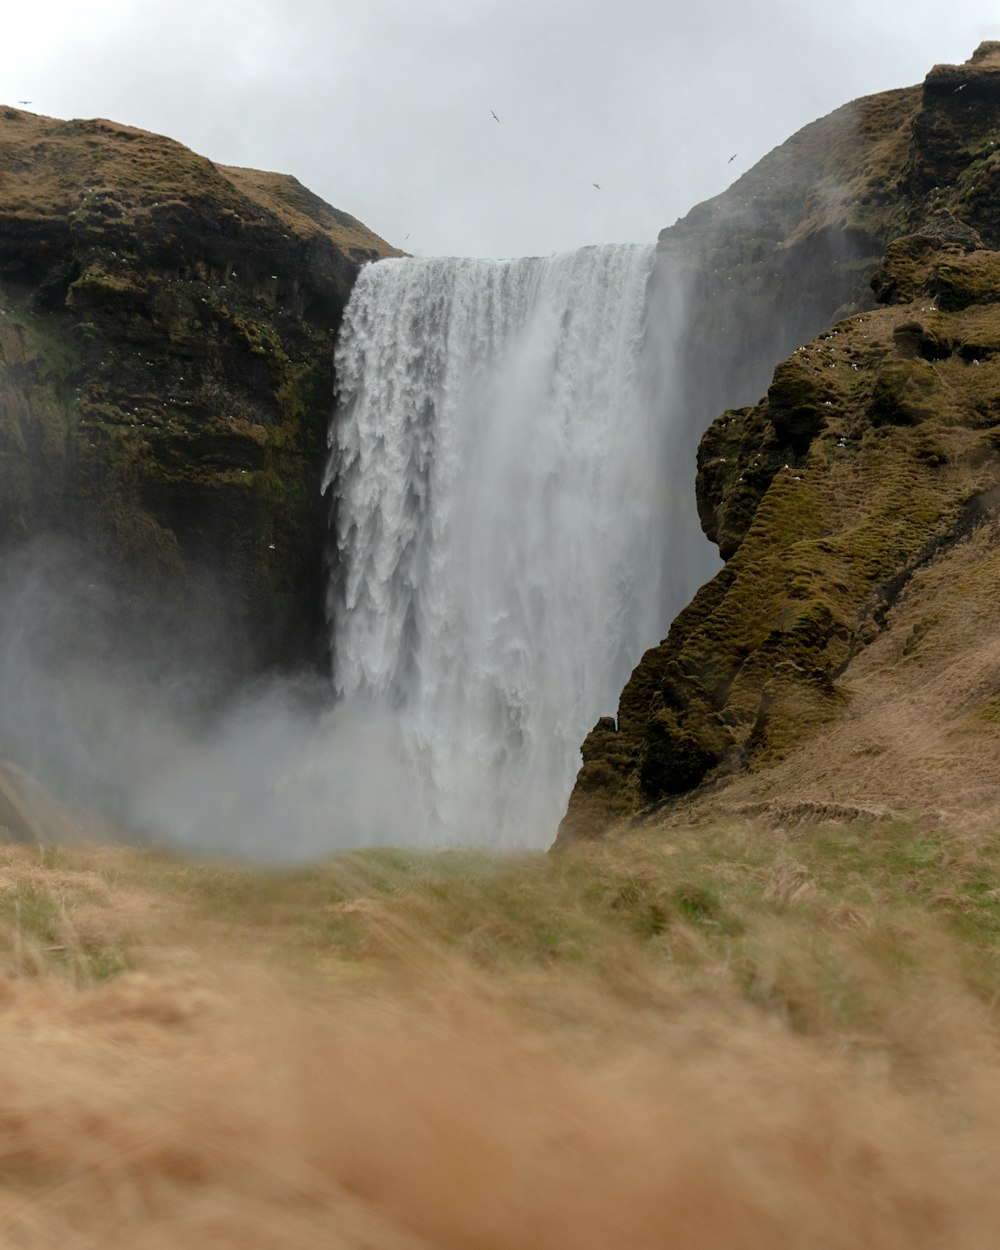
[0, 539, 430, 863]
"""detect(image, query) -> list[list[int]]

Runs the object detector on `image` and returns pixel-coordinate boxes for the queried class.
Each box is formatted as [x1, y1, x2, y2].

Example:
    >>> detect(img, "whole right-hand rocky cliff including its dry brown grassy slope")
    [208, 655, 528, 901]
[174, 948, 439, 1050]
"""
[559, 44, 1000, 841]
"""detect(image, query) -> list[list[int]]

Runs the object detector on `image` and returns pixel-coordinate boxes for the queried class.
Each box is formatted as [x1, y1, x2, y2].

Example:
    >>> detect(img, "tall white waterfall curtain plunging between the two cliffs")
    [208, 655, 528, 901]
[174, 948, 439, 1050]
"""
[328, 245, 693, 846]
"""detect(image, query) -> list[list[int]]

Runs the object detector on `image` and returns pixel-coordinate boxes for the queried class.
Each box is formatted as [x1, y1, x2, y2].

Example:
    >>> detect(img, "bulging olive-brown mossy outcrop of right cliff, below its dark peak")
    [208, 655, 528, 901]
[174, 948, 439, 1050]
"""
[570, 220, 1000, 831]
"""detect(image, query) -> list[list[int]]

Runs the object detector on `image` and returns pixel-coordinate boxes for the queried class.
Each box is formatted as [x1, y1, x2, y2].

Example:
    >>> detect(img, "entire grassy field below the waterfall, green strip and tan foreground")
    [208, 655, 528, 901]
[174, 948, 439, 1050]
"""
[0, 823, 1000, 1250]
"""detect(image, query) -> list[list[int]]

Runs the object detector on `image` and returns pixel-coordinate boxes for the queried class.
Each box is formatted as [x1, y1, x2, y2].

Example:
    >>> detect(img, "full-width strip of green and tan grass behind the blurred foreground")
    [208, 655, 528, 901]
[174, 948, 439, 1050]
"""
[0, 821, 1000, 1036]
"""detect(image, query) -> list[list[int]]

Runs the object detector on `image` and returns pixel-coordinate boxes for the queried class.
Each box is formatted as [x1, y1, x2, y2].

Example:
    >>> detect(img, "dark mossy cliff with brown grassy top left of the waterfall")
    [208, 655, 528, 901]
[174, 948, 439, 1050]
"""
[0, 108, 394, 668]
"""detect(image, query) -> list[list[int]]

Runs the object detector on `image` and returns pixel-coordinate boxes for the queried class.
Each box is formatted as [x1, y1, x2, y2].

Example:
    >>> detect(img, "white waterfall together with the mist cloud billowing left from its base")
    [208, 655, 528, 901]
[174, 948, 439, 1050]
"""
[0, 238, 718, 863]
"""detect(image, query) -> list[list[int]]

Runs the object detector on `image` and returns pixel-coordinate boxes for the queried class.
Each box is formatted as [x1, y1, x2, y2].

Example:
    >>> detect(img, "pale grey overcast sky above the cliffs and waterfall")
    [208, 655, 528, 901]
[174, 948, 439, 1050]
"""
[0, 0, 1000, 256]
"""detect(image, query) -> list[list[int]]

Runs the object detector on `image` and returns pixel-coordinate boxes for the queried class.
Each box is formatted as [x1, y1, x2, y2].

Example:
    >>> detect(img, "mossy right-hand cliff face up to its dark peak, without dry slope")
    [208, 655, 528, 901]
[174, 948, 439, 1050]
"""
[559, 45, 1000, 841]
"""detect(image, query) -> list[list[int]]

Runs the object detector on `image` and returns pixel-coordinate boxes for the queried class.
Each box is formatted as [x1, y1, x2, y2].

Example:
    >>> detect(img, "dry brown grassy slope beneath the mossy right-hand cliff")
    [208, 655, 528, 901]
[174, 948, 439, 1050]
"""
[681, 507, 1000, 830]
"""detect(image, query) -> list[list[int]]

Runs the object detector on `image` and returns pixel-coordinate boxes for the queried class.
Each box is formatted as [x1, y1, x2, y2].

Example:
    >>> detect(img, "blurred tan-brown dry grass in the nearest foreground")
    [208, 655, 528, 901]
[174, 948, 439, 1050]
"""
[0, 955, 1000, 1250]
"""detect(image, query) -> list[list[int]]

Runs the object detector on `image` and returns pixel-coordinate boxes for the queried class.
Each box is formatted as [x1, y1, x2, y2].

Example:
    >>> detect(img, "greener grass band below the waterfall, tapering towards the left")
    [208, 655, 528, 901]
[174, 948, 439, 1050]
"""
[91, 823, 1000, 1033]
